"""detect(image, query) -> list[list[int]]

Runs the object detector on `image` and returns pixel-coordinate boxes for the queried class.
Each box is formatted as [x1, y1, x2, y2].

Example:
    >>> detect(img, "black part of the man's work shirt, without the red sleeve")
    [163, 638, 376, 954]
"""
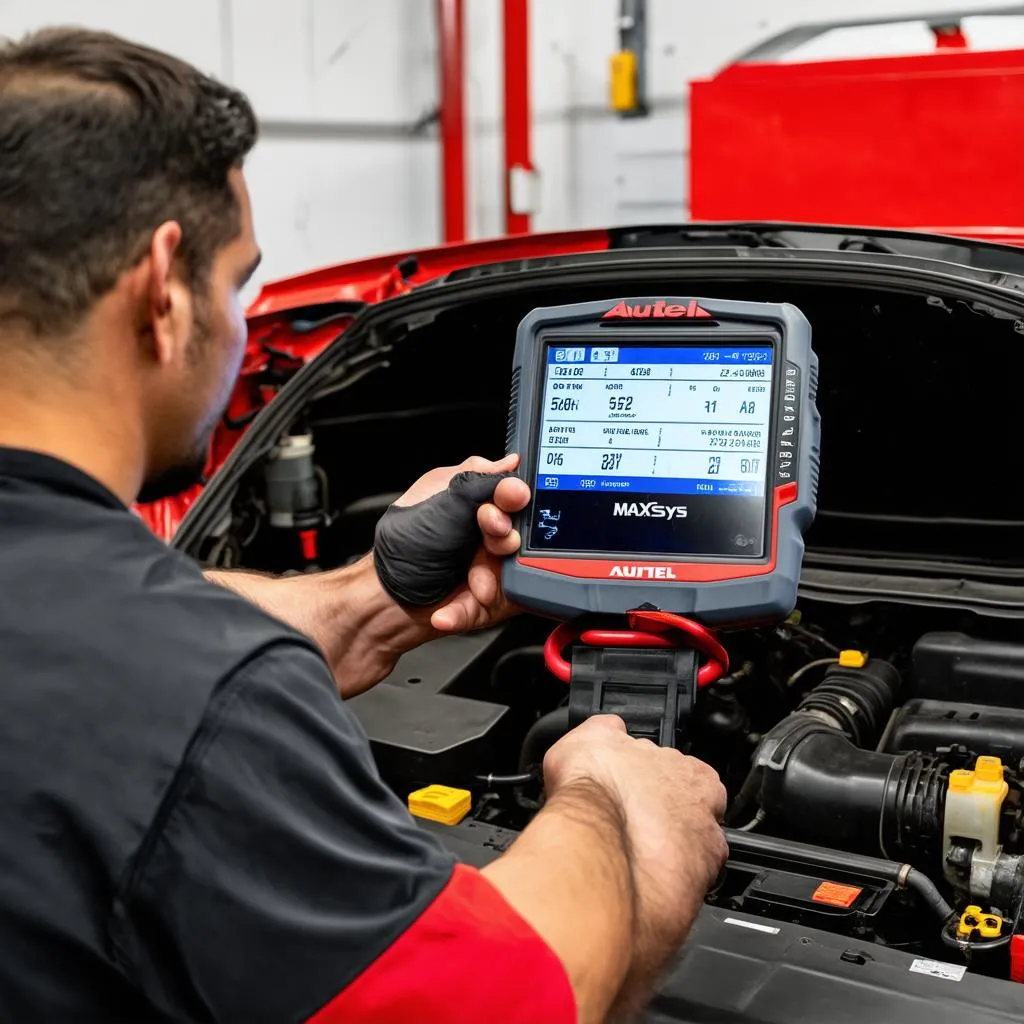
[0, 449, 453, 1024]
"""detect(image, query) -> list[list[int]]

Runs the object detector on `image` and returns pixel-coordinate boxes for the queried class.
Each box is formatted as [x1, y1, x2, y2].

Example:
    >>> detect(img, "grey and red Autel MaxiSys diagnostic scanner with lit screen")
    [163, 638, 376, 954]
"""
[504, 295, 820, 625]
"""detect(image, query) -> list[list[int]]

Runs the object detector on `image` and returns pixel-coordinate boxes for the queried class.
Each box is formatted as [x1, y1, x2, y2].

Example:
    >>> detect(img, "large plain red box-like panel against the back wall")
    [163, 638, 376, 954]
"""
[689, 48, 1024, 245]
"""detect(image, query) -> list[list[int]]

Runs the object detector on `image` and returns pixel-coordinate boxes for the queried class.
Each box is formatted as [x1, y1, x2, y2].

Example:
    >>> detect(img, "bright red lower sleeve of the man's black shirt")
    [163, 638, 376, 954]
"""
[306, 864, 577, 1024]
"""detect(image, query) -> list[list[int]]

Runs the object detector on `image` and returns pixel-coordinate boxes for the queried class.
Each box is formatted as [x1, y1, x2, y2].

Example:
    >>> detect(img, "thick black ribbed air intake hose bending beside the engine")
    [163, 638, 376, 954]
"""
[743, 660, 948, 862]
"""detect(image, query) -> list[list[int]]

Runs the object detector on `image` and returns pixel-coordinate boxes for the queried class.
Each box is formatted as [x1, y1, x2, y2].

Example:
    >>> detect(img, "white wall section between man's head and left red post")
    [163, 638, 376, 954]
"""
[0, 0, 440, 294]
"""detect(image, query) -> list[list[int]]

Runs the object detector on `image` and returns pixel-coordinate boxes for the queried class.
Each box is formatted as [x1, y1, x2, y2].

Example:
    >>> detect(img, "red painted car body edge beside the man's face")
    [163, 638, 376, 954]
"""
[135, 230, 610, 541]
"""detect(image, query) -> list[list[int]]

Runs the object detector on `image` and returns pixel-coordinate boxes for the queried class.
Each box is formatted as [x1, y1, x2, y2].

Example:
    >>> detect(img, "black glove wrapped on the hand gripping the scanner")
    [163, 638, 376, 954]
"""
[374, 472, 514, 607]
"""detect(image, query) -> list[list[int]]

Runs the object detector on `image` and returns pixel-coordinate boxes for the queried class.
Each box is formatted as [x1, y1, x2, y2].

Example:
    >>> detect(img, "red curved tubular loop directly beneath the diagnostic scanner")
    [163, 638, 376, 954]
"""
[544, 611, 729, 687]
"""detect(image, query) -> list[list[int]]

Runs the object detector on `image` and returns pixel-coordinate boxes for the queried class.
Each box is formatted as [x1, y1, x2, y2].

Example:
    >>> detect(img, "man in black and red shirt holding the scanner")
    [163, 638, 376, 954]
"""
[0, 29, 725, 1024]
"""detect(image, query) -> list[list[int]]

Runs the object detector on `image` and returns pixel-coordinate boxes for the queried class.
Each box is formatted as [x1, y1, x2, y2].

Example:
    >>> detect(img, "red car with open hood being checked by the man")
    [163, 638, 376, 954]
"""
[159, 223, 1024, 1024]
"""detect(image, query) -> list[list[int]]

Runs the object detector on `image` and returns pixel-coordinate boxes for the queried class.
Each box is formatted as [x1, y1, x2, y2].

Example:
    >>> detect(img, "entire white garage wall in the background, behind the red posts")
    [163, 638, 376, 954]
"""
[0, 0, 1024, 294]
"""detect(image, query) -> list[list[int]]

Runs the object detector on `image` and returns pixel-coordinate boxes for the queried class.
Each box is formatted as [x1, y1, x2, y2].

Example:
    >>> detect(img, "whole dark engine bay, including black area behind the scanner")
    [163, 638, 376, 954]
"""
[186, 282, 1024, 995]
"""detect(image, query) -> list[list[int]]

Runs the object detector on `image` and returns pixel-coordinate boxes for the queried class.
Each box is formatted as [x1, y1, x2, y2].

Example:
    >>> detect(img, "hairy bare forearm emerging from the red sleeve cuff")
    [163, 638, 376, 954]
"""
[483, 781, 635, 1024]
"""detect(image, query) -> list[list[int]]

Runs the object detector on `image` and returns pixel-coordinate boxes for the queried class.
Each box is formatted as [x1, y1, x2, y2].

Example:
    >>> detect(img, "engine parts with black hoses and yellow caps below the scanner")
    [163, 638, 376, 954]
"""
[342, 613, 1024, 978]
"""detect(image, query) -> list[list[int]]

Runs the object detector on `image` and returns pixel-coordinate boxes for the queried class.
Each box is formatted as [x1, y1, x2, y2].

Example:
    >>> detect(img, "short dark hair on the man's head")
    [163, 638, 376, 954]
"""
[0, 29, 257, 335]
